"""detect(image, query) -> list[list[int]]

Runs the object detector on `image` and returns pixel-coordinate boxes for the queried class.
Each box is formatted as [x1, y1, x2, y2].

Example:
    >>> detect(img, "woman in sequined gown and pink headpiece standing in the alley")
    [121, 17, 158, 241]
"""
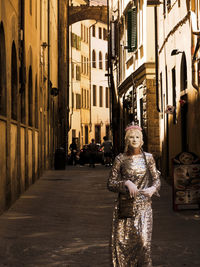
[108, 123, 160, 267]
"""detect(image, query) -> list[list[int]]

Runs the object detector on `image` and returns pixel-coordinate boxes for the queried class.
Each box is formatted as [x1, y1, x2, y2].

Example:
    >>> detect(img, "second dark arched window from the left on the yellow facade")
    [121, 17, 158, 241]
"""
[11, 42, 17, 120]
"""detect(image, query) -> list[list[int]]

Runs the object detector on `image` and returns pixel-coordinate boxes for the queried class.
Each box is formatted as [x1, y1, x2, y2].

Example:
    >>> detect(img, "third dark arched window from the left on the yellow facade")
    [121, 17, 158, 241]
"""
[28, 66, 33, 126]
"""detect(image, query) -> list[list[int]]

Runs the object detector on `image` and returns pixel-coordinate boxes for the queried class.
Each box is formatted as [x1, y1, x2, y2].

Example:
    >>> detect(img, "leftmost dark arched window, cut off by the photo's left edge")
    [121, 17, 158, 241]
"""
[0, 23, 6, 116]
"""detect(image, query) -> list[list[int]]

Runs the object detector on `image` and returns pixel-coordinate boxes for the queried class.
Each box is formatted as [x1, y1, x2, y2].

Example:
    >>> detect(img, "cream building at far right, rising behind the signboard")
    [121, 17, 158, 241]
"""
[158, 0, 200, 176]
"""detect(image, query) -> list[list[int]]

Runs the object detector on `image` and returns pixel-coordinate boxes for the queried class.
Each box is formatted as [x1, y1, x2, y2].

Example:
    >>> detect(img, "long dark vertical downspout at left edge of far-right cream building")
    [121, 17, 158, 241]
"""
[154, 6, 160, 112]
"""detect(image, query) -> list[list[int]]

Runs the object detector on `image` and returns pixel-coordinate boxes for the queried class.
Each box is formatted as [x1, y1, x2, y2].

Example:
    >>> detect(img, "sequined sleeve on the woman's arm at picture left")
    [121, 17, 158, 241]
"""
[107, 155, 127, 193]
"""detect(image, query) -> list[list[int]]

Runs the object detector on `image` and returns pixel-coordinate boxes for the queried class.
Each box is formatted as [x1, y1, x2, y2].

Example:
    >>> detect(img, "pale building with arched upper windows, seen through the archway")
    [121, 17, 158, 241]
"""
[89, 22, 110, 143]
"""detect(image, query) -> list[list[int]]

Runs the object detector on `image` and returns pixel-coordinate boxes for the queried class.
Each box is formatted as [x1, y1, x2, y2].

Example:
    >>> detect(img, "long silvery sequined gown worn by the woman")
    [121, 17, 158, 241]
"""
[108, 152, 160, 267]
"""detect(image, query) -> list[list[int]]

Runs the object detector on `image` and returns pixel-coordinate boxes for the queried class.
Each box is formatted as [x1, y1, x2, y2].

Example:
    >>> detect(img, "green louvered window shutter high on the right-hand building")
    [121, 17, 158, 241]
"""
[127, 7, 137, 52]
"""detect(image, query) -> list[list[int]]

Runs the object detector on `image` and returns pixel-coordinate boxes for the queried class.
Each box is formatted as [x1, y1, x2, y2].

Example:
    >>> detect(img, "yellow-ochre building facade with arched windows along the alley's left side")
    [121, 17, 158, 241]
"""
[0, 0, 58, 213]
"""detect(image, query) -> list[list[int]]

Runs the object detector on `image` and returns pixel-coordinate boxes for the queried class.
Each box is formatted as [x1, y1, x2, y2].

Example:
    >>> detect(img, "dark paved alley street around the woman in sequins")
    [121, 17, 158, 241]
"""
[0, 165, 200, 267]
